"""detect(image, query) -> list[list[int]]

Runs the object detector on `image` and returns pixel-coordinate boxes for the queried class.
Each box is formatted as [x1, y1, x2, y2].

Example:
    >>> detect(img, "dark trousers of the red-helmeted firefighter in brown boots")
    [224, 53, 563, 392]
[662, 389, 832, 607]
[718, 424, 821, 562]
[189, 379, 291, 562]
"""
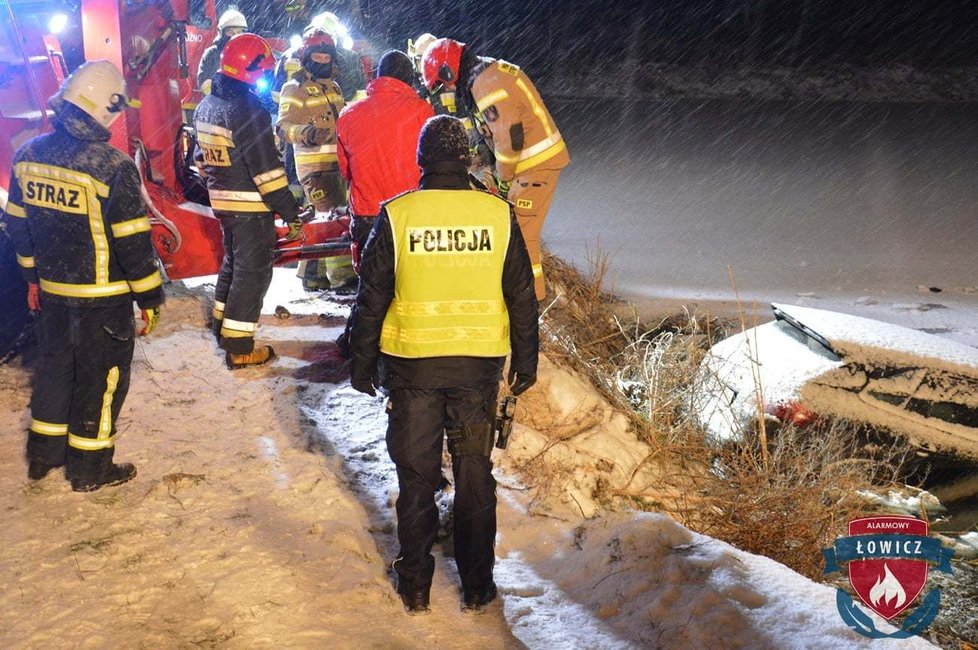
[214, 215, 276, 354]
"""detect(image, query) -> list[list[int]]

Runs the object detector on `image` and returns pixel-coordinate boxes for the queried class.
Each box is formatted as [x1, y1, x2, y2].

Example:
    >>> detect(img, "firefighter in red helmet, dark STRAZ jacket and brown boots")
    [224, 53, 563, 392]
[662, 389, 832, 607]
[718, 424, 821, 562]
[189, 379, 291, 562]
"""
[194, 34, 301, 369]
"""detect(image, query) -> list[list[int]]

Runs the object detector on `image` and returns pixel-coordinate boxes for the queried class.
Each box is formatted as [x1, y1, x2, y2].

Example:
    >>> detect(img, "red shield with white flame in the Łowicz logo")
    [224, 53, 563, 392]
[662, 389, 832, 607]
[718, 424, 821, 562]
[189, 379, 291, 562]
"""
[848, 516, 928, 620]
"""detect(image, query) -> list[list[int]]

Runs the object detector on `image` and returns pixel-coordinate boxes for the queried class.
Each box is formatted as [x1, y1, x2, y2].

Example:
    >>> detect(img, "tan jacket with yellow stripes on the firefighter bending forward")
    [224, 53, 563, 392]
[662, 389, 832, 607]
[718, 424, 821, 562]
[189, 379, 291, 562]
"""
[471, 59, 570, 181]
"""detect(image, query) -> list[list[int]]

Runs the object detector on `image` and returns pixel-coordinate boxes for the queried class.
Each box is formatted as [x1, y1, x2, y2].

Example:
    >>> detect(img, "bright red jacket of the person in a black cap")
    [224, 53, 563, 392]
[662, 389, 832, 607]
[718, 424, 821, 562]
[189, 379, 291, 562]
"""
[336, 77, 434, 217]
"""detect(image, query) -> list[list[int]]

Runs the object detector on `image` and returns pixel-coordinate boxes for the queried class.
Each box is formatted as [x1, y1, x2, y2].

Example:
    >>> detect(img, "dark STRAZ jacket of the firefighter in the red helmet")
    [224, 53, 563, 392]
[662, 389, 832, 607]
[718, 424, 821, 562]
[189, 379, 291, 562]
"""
[194, 72, 299, 221]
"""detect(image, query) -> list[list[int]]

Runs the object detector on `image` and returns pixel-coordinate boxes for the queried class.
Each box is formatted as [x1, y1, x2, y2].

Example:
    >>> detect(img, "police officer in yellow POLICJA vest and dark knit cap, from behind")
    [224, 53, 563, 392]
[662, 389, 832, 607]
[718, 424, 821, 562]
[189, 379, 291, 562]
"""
[351, 115, 539, 614]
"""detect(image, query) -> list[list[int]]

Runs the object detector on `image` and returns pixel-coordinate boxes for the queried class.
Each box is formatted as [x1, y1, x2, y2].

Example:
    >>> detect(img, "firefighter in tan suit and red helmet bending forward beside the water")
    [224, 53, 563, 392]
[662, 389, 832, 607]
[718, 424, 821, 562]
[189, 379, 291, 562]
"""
[422, 38, 570, 300]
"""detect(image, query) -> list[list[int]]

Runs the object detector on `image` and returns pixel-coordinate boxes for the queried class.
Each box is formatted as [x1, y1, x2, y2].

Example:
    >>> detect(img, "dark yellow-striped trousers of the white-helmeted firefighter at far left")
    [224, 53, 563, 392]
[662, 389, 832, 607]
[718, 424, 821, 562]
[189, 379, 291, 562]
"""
[27, 294, 135, 479]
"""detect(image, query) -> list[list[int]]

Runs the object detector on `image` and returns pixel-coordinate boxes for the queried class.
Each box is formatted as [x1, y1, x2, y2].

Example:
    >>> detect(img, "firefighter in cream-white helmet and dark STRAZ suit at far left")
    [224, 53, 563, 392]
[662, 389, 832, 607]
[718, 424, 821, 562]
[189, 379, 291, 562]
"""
[5, 61, 164, 492]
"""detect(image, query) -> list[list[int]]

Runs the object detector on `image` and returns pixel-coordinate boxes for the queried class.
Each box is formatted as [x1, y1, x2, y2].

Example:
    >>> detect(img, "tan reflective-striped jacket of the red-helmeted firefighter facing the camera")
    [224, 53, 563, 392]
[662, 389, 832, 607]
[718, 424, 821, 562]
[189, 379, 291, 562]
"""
[276, 71, 344, 179]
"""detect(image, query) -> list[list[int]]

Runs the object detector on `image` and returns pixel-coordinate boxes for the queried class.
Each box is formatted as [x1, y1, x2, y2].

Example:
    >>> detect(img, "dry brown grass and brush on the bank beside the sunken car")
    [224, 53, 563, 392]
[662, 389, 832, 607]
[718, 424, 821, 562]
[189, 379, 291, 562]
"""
[542, 251, 920, 579]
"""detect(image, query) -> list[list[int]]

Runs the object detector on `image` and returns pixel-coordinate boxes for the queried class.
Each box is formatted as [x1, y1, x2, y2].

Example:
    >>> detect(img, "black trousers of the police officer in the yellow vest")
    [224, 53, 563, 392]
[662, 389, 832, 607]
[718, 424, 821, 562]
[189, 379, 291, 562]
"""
[387, 383, 499, 591]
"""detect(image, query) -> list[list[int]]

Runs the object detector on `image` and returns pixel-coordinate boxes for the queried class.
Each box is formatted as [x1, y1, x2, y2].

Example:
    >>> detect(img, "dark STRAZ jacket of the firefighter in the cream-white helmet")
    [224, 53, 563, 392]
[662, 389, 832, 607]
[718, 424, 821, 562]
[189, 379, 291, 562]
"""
[5, 103, 163, 309]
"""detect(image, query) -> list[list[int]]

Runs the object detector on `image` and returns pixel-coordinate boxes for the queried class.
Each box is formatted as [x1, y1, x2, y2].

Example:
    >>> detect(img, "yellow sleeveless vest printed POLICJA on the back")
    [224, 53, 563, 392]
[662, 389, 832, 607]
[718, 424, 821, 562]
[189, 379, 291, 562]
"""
[380, 190, 510, 359]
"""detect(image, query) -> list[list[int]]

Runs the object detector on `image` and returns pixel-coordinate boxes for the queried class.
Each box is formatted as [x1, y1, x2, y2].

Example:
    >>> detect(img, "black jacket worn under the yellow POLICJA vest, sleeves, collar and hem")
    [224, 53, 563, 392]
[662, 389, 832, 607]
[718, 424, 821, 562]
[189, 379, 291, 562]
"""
[351, 163, 539, 388]
